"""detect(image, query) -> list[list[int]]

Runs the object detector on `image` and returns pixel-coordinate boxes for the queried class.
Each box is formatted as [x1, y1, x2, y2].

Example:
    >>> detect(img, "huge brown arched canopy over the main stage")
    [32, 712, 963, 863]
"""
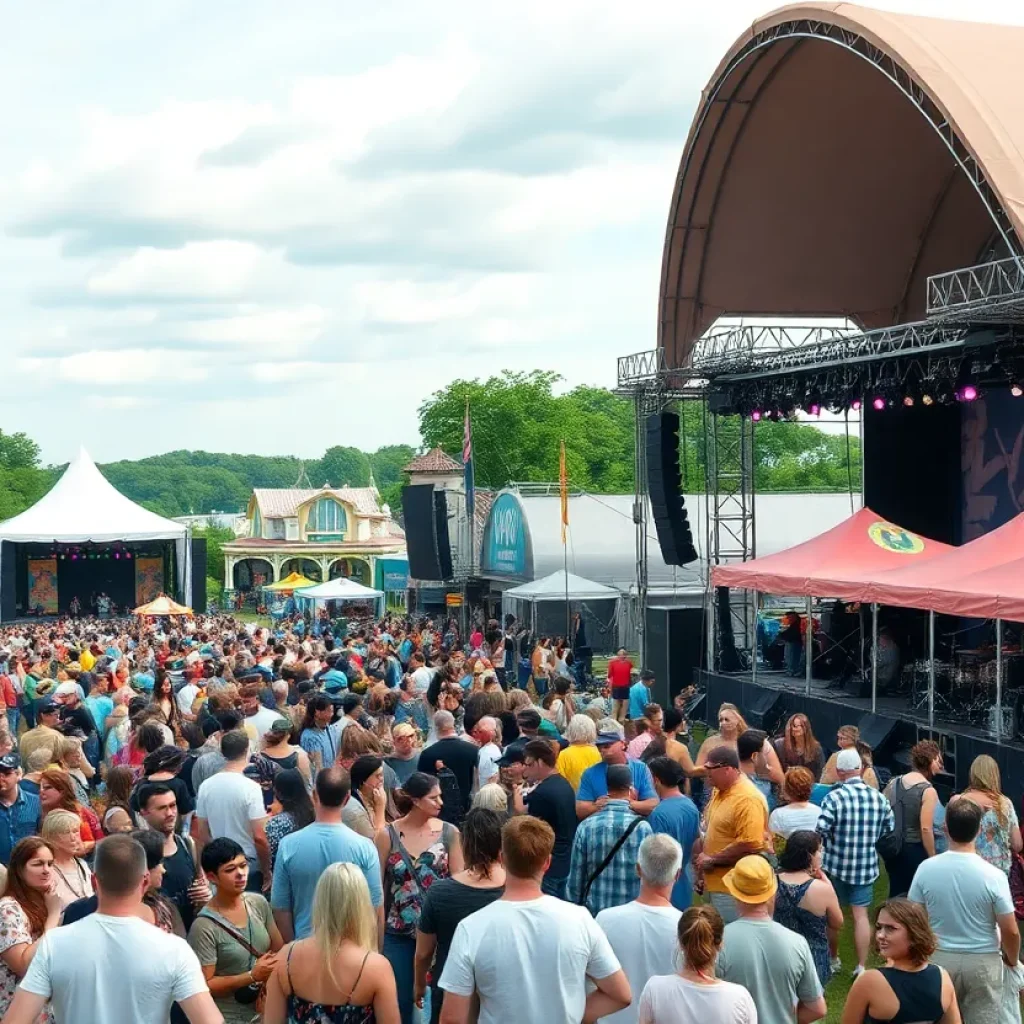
[658, 2, 1024, 367]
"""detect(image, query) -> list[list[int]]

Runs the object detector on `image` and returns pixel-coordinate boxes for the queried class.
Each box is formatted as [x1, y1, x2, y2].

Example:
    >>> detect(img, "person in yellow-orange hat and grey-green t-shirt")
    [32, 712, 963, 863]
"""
[716, 855, 827, 1024]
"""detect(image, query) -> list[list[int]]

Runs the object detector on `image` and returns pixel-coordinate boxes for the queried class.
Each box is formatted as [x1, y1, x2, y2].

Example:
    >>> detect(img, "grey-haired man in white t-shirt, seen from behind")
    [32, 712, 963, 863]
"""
[597, 834, 683, 1024]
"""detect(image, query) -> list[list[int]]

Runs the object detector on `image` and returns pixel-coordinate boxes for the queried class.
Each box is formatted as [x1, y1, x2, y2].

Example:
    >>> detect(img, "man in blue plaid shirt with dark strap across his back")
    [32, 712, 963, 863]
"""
[566, 765, 653, 914]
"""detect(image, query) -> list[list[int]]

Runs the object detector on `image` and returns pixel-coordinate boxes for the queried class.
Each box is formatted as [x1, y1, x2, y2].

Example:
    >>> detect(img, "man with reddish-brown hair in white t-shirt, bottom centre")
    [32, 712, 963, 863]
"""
[439, 815, 631, 1024]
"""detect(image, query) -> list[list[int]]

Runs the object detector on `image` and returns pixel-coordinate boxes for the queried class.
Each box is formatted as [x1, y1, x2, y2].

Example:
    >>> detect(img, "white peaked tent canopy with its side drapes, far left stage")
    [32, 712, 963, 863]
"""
[0, 447, 193, 618]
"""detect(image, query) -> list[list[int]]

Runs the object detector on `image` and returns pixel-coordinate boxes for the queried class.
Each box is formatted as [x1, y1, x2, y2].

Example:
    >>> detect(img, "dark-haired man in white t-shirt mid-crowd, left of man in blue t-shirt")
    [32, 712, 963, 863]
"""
[191, 729, 270, 892]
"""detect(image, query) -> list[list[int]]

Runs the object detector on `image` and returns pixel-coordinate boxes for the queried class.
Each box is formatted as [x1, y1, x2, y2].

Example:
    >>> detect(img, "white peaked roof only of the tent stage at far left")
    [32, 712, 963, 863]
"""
[0, 447, 188, 544]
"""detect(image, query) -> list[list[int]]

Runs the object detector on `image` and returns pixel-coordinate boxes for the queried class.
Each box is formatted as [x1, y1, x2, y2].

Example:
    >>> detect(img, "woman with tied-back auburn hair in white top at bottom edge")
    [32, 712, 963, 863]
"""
[639, 905, 758, 1024]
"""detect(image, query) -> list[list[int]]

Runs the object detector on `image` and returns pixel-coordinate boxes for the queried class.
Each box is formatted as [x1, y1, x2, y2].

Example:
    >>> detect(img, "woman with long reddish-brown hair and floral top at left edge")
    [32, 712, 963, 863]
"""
[0, 836, 60, 1021]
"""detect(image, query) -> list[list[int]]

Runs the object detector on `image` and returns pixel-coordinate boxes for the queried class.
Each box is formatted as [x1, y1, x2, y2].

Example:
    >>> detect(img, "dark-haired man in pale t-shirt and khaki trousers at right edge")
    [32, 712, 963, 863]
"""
[908, 797, 1021, 1024]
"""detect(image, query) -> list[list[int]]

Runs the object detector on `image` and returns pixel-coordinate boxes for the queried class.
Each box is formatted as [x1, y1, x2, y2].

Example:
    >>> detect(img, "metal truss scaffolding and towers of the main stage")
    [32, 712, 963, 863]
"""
[616, 250, 1024, 684]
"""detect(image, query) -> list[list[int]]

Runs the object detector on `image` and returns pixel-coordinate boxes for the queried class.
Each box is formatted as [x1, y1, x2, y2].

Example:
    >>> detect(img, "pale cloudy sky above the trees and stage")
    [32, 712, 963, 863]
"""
[0, 0, 1024, 462]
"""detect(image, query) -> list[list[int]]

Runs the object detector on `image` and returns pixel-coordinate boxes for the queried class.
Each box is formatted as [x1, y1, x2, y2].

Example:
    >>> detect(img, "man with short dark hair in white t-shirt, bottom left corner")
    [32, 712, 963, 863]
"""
[4, 835, 223, 1024]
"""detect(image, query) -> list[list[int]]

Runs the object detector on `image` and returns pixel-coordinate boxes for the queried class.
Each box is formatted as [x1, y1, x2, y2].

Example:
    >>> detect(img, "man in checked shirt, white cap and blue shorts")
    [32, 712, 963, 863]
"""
[817, 749, 896, 977]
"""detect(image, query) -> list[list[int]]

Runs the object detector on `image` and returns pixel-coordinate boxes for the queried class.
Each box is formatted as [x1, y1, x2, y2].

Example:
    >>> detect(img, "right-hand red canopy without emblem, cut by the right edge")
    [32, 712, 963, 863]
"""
[864, 513, 1024, 620]
